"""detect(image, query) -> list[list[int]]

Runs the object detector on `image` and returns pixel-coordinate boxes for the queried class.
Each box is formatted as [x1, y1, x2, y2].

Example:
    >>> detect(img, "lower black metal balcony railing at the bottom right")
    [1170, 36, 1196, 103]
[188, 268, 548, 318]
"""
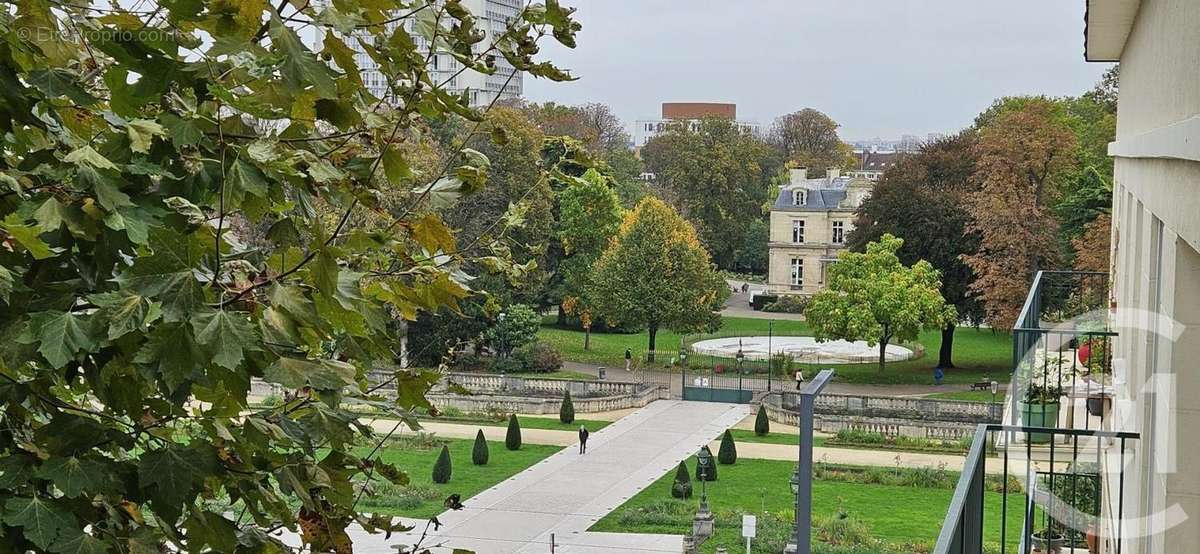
[934, 424, 1138, 554]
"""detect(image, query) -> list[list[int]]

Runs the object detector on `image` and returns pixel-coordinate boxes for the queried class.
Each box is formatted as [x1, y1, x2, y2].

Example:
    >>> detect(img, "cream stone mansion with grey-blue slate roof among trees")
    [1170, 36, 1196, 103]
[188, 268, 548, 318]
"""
[767, 168, 875, 296]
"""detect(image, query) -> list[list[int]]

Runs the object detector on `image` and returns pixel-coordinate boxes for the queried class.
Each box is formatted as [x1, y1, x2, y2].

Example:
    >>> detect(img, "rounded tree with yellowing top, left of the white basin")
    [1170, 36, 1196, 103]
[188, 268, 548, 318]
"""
[593, 197, 730, 353]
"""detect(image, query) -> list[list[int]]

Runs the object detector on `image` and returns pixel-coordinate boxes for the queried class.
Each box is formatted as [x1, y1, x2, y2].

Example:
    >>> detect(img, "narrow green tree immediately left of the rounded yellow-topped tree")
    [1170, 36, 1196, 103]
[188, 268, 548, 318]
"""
[558, 169, 624, 348]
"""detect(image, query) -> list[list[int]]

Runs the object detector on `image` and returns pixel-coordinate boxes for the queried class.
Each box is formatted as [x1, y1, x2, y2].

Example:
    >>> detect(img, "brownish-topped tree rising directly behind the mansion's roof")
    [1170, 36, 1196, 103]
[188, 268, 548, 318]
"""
[769, 108, 850, 171]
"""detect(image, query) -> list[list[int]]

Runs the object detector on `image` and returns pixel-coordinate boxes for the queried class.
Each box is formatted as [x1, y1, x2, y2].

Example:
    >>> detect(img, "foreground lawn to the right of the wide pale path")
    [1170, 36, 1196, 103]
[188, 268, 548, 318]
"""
[590, 458, 1024, 552]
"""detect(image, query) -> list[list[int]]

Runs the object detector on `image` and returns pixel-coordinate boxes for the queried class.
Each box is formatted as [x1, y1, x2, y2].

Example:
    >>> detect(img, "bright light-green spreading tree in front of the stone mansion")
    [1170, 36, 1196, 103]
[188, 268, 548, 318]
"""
[805, 235, 955, 371]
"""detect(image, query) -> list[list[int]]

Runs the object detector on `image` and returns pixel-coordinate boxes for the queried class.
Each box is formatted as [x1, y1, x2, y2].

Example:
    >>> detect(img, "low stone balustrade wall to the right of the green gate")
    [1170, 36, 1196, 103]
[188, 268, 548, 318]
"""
[762, 392, 1003, 440]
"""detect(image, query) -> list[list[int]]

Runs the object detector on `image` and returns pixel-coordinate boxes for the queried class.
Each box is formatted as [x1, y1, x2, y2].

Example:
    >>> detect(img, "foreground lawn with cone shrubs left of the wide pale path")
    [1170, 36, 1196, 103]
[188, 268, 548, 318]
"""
[356, 439, 562, 518]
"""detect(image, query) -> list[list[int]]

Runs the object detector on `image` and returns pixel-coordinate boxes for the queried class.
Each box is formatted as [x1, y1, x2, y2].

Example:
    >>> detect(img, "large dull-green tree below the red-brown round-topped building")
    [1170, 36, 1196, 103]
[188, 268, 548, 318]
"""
[642, 118, 784, 269]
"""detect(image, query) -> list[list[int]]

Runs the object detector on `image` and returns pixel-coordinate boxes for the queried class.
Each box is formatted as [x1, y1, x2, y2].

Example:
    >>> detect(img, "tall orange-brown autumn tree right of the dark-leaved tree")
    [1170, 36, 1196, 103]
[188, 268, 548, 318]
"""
[964, 98, 1075, 329]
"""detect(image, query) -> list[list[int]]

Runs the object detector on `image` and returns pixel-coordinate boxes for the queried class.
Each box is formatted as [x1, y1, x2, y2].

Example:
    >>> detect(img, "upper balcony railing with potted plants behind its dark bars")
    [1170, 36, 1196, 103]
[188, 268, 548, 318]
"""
[1007, 271, 1117, 429]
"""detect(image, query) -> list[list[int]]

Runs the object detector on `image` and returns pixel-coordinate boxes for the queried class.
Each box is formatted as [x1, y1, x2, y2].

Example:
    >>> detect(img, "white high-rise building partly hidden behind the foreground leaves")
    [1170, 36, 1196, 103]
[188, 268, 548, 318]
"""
[314, 0, 522, 106]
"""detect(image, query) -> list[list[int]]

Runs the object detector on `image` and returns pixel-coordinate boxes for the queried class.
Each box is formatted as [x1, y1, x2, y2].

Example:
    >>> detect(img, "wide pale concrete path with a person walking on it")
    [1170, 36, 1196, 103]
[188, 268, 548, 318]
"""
[354, 401, 750, 554]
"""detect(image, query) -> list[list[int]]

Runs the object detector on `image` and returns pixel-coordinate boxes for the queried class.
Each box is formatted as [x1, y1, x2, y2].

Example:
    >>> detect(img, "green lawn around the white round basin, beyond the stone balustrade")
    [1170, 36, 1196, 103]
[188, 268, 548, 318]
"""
[538, 318, 1013, 385]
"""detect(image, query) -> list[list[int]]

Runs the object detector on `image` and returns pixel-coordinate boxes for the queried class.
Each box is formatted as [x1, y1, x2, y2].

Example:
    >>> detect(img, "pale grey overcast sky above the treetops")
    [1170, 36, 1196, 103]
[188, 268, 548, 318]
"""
[524, 0, 1108, 139]
